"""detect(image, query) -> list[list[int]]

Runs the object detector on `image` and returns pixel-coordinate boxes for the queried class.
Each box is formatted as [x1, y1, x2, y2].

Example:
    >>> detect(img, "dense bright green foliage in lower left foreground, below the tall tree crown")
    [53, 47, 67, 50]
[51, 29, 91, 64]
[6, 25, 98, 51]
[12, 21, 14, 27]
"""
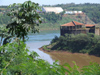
[0, 41, 65, 75]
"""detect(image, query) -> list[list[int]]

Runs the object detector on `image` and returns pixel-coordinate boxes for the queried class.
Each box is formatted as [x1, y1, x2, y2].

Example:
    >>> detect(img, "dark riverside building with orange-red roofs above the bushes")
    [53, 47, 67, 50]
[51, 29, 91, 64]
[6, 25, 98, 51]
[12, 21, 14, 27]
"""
[60, 21, 100, 35]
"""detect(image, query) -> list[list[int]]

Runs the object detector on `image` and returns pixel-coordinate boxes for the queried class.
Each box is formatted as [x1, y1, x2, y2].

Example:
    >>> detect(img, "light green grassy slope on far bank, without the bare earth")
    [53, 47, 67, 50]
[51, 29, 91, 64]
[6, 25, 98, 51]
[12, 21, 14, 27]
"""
[39, 16, 81, 30]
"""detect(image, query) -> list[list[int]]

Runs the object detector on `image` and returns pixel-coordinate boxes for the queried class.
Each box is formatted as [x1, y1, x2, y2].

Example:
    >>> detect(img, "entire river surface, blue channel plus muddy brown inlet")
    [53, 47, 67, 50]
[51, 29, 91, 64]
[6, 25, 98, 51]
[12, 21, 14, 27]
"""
[26, 30, 100, 67]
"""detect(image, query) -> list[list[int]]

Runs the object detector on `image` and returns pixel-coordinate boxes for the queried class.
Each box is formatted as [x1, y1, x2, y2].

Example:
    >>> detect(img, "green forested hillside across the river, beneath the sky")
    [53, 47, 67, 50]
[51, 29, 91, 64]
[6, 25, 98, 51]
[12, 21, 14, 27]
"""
[0, 3, 100, 30]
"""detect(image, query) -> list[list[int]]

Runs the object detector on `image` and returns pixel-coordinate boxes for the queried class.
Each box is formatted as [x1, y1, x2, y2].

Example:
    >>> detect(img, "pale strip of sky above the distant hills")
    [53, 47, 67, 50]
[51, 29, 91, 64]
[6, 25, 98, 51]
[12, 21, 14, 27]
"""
[0, 0, 100, 6]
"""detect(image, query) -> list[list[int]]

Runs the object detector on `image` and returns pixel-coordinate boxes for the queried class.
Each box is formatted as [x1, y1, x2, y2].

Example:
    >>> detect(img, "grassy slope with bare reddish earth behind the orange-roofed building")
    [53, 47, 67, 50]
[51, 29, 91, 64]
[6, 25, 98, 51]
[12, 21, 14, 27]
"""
[40, 14, 94, 30]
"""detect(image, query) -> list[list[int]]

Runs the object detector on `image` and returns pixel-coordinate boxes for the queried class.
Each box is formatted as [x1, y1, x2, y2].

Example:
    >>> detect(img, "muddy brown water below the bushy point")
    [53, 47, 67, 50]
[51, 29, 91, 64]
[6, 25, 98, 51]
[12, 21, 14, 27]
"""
[39, 48, 100, 68]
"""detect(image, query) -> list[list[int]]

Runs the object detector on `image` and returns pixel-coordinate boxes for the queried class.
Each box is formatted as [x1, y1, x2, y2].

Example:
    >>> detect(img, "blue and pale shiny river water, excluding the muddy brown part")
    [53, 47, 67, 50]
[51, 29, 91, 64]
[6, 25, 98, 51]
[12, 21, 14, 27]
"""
[26, 30, 60, 64]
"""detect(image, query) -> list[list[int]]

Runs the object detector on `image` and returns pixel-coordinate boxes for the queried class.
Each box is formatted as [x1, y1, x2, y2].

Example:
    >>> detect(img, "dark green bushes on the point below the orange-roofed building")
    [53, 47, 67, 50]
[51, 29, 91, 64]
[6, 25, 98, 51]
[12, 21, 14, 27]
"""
[43, 33, 100, 56]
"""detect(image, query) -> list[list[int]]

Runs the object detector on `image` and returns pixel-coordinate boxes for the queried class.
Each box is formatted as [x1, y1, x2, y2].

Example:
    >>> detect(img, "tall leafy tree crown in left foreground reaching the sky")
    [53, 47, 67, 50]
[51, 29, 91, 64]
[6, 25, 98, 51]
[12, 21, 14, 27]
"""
[7, 1, 42, 41]
